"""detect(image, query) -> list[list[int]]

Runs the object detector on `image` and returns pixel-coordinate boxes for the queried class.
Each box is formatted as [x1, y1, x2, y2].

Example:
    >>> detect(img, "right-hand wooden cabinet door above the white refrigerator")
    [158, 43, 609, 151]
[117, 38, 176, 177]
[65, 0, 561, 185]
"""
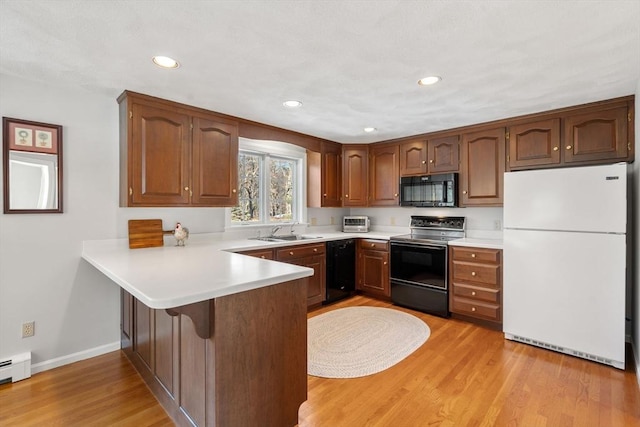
[564, 107, 630, 163]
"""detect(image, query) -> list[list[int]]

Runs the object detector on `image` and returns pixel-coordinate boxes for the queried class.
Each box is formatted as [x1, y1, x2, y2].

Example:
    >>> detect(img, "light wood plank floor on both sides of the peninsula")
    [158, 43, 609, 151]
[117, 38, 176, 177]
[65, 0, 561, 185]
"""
[0, 296, 640, 427]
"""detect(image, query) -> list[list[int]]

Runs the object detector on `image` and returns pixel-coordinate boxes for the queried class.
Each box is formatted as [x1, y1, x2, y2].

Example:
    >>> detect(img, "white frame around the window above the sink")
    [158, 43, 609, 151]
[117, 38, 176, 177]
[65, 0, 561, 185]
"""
[225, 138, 307, 229]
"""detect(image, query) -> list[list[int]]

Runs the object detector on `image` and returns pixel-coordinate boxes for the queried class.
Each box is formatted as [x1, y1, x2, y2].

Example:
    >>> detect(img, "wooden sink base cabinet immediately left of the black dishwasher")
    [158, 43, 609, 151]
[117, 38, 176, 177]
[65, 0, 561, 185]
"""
[275, 243, 326, 307]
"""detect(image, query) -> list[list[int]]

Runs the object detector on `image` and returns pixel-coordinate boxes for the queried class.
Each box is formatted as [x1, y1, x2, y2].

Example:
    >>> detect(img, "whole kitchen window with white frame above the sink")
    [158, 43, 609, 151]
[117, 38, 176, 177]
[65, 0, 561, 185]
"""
[230, 138, 306, 226]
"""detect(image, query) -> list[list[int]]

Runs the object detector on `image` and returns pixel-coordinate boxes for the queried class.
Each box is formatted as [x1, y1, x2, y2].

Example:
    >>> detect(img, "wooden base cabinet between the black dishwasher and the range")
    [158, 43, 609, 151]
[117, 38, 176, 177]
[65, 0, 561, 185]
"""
[356, 239, 391, 299]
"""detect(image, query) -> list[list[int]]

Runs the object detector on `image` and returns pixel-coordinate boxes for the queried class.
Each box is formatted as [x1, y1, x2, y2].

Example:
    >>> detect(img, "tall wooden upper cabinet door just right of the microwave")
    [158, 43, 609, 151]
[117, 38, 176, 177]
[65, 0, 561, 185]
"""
[460, 128, 505, 206]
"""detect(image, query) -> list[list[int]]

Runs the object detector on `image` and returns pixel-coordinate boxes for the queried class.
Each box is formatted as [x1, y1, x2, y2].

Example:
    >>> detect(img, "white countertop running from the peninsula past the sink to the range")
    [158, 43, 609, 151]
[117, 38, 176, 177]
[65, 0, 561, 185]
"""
[82, 232, 394, 309]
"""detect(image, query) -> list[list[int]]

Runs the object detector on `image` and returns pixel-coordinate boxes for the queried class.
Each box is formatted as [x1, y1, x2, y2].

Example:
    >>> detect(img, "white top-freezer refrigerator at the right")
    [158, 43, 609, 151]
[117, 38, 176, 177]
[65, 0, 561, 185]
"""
[503, 164, 627, 369]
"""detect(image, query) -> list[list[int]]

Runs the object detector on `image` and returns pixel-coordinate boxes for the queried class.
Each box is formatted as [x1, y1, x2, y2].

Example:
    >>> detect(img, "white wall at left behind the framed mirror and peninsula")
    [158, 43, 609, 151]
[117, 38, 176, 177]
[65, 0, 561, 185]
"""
[0, 74, 230, 371]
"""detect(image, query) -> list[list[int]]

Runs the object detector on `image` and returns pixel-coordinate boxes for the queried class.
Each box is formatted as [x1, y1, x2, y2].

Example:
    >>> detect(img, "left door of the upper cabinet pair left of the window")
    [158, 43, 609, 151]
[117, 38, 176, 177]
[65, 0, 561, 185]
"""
[128, 104, 191, 206]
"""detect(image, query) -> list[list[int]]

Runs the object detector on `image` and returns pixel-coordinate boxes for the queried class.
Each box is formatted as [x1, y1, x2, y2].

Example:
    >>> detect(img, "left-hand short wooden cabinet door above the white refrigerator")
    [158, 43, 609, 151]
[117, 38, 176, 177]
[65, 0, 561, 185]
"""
[509, 119, 560, 169]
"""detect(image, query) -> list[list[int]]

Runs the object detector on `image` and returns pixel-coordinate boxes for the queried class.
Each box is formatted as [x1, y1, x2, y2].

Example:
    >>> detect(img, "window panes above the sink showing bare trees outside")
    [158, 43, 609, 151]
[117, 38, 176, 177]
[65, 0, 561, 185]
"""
[231, 151, 298, 224]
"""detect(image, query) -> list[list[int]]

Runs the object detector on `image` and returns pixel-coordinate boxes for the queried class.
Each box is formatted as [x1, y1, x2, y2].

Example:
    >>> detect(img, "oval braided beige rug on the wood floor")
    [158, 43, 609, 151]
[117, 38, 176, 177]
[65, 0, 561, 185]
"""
[307, 307, 431, 378]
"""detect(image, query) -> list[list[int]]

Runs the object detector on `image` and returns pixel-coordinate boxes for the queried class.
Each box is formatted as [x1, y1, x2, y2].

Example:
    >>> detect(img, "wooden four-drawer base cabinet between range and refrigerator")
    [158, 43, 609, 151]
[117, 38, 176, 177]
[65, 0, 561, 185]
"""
[449, 246, 502, 327]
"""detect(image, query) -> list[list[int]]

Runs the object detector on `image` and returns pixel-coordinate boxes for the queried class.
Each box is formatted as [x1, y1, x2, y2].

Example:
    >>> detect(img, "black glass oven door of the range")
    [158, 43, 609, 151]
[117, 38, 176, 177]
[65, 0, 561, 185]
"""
[391, 241, 447, 290]
